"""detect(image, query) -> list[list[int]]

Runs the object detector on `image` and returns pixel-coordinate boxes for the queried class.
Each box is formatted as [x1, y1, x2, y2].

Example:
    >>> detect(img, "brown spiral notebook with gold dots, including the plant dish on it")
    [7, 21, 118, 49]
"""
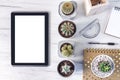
[83, 48, 120, 80]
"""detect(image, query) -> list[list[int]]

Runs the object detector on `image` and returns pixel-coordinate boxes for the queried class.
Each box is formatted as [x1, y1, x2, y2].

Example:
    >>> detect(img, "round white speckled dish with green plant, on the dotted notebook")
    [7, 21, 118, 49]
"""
[91, 54, 115, 78]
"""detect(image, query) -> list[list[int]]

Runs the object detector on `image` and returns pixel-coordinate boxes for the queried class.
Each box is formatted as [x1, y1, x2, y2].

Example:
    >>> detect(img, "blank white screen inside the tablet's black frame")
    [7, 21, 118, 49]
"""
[15, 15, 45, 63]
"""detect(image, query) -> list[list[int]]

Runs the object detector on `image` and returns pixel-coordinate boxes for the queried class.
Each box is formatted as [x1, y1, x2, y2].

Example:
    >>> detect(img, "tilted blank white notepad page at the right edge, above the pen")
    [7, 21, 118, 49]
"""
[105, 7, 120, 38]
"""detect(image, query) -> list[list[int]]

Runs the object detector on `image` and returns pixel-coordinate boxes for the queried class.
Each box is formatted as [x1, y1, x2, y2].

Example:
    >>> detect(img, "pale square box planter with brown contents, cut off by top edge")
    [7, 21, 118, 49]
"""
[84, 0, 109, 16]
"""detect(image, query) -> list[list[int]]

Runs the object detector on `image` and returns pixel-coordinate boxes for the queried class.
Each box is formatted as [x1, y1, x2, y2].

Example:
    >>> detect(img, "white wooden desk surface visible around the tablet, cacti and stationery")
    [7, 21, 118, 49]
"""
[0, 0, 120, 80]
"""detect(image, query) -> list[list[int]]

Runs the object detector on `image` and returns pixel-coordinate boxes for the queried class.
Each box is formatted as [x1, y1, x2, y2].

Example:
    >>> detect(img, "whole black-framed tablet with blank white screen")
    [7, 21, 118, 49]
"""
[11, 12, 49, 65]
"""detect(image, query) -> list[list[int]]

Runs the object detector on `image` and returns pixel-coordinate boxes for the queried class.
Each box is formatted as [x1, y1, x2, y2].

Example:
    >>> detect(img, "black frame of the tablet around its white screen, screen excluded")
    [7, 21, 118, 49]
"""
[11, 12, 49, 66]
